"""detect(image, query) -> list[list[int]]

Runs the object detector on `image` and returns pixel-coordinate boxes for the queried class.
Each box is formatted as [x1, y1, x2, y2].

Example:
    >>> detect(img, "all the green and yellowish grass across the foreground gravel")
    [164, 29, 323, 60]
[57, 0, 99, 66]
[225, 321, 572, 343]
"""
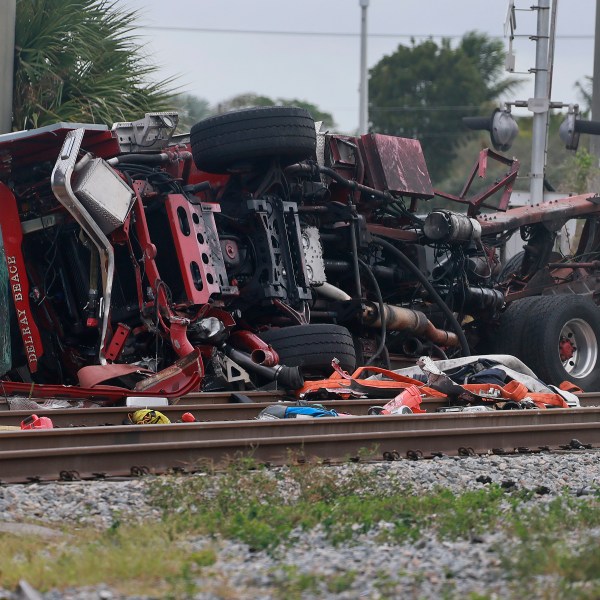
[0, 461, 600, 600]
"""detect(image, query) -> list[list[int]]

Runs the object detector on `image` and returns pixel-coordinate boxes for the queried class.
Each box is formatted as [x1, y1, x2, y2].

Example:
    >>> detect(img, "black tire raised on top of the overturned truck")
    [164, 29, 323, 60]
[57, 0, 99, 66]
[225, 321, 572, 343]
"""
[190, 106, 317, 173]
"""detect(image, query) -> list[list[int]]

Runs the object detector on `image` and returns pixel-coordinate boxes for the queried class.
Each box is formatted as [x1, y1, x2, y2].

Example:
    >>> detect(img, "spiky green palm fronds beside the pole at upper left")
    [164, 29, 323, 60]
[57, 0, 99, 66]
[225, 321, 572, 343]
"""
[13, 0, 172, 129]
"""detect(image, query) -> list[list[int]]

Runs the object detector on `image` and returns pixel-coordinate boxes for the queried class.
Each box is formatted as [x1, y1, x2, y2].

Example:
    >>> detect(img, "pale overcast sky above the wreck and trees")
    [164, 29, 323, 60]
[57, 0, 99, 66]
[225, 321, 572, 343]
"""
[119, 0, 596, 133]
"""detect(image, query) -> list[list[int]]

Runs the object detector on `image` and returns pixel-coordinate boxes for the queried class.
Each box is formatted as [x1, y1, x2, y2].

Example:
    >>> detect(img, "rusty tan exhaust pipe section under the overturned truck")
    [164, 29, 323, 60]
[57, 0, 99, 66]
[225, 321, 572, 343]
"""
[363, 302, 460, 346]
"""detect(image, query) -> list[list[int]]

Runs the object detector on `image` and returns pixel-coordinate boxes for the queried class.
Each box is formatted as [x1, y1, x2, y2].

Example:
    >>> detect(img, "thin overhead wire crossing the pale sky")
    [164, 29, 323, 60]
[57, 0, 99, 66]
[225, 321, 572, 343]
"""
[138, 25, 594, 40]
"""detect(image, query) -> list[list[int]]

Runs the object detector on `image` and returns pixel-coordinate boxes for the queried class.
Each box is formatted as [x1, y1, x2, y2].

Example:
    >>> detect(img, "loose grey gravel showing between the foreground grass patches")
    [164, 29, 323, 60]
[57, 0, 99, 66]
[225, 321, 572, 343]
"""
[0, 451, 600, 600]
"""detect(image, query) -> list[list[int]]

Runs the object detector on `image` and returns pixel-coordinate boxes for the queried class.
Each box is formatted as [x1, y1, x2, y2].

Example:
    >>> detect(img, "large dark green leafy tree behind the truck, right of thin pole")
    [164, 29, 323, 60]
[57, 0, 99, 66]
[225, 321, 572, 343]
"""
[369, 32, 518, 181]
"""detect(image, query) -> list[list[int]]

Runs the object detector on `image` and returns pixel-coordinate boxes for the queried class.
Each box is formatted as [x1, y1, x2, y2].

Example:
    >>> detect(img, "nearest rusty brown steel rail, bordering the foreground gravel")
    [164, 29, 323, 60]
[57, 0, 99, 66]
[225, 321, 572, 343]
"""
[0, 423, 599, 483]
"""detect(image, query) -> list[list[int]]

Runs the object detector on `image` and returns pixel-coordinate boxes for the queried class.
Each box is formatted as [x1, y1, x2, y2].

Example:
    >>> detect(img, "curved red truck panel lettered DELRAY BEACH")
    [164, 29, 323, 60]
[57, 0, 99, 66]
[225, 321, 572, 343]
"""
[0, 182, 44, 373]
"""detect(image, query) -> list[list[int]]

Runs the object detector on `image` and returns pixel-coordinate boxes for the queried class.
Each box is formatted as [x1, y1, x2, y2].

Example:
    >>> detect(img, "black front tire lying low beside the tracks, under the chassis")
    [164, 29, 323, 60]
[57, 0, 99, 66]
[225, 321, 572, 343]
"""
[258, 323, 356, 376]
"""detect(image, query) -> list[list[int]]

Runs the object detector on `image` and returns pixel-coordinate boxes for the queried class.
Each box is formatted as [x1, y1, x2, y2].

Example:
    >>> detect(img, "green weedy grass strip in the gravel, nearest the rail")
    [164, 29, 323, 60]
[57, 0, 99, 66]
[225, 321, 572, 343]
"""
[148, 465, 519, 550]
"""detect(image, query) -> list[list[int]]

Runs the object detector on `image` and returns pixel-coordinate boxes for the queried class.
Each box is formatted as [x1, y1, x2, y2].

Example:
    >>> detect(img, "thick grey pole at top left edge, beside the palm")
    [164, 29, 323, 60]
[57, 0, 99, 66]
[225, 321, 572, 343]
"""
[0, 0, 17, 133]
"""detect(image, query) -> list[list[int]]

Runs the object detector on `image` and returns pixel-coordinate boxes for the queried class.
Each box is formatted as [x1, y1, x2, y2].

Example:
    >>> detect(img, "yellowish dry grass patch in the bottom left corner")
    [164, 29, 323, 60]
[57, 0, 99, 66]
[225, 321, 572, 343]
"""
[0, 521, 216, 598]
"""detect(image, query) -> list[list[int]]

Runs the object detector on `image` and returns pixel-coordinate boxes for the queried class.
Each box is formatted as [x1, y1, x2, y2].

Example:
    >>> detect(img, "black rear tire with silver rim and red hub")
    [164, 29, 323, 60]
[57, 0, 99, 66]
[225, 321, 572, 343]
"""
[522, 295, 600, 392]
